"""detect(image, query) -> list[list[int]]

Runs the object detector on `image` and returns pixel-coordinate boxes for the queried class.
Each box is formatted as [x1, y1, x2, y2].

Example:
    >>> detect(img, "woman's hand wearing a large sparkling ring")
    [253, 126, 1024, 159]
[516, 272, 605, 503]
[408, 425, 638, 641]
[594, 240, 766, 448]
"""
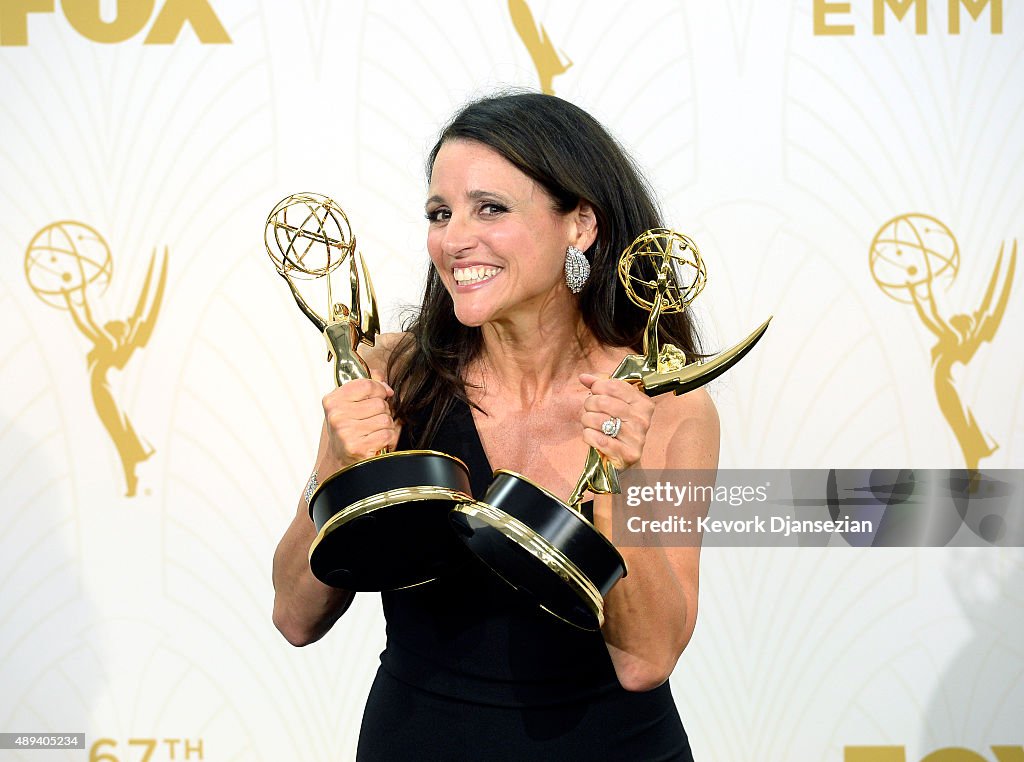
[580, 373, 654, 471]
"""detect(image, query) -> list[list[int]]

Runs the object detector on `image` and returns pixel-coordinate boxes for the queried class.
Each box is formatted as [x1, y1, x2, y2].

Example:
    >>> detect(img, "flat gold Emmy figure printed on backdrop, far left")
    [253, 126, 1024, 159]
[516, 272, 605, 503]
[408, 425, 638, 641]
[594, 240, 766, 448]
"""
[25, 220, 167, 497]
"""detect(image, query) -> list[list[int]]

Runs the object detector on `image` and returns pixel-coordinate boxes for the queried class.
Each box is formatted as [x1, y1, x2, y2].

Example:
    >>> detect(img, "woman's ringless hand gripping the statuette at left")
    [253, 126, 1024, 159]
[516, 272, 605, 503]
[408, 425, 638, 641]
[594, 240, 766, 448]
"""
[324, 378, 398, 471]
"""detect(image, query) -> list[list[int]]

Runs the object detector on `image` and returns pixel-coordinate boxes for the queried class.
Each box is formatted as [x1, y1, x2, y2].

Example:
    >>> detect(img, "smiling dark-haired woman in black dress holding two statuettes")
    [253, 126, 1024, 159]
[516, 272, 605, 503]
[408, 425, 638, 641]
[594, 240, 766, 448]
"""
[274, 94, 719, 760]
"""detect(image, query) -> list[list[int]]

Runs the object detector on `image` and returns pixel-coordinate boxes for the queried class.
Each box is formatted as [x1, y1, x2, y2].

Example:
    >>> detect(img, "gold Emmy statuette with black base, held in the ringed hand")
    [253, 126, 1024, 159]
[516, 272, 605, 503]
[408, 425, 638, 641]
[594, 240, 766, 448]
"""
[452, 228, 771, 630]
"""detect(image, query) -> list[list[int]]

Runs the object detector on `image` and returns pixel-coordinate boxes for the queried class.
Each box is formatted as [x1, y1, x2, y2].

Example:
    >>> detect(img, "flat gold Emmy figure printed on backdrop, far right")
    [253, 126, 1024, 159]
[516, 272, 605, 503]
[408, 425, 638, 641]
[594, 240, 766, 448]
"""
[869, 214, 1017, 469]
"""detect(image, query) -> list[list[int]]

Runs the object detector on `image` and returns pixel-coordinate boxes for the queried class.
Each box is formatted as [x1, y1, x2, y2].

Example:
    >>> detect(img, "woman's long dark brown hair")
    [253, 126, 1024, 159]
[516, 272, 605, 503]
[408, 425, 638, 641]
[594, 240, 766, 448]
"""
[388, 93, 699, 447]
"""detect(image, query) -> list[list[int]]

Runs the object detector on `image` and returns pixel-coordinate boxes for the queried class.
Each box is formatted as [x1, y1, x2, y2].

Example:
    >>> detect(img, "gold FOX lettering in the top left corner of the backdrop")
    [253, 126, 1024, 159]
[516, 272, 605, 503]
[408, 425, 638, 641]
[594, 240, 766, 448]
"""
[0, 0, 231, 46]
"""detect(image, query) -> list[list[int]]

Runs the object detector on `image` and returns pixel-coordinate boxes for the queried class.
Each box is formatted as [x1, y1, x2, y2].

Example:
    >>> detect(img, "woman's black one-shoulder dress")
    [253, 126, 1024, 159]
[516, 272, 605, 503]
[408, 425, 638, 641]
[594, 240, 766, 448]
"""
[356, 400, 692, 762]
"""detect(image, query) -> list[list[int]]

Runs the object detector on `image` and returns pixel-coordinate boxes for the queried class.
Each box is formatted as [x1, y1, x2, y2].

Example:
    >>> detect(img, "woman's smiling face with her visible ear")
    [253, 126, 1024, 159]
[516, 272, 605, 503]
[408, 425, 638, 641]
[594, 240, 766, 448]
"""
[426, 140, 590, 326]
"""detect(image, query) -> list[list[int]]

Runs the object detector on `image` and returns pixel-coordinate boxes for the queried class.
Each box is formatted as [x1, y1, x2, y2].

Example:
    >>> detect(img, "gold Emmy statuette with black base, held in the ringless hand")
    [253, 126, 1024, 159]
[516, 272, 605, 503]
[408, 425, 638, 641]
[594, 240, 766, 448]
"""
[264, 194, 471, 591]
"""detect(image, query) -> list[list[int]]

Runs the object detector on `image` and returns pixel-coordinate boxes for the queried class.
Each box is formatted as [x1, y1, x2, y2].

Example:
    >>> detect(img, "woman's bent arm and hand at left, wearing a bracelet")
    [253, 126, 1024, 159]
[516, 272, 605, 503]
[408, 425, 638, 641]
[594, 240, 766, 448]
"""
[272, 336, 398, 645]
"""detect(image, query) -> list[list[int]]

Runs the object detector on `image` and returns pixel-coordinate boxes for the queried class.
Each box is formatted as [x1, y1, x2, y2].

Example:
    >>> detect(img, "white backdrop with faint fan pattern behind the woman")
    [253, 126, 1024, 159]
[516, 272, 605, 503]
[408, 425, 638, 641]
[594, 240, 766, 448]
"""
[0, 0, 1024, 762]
